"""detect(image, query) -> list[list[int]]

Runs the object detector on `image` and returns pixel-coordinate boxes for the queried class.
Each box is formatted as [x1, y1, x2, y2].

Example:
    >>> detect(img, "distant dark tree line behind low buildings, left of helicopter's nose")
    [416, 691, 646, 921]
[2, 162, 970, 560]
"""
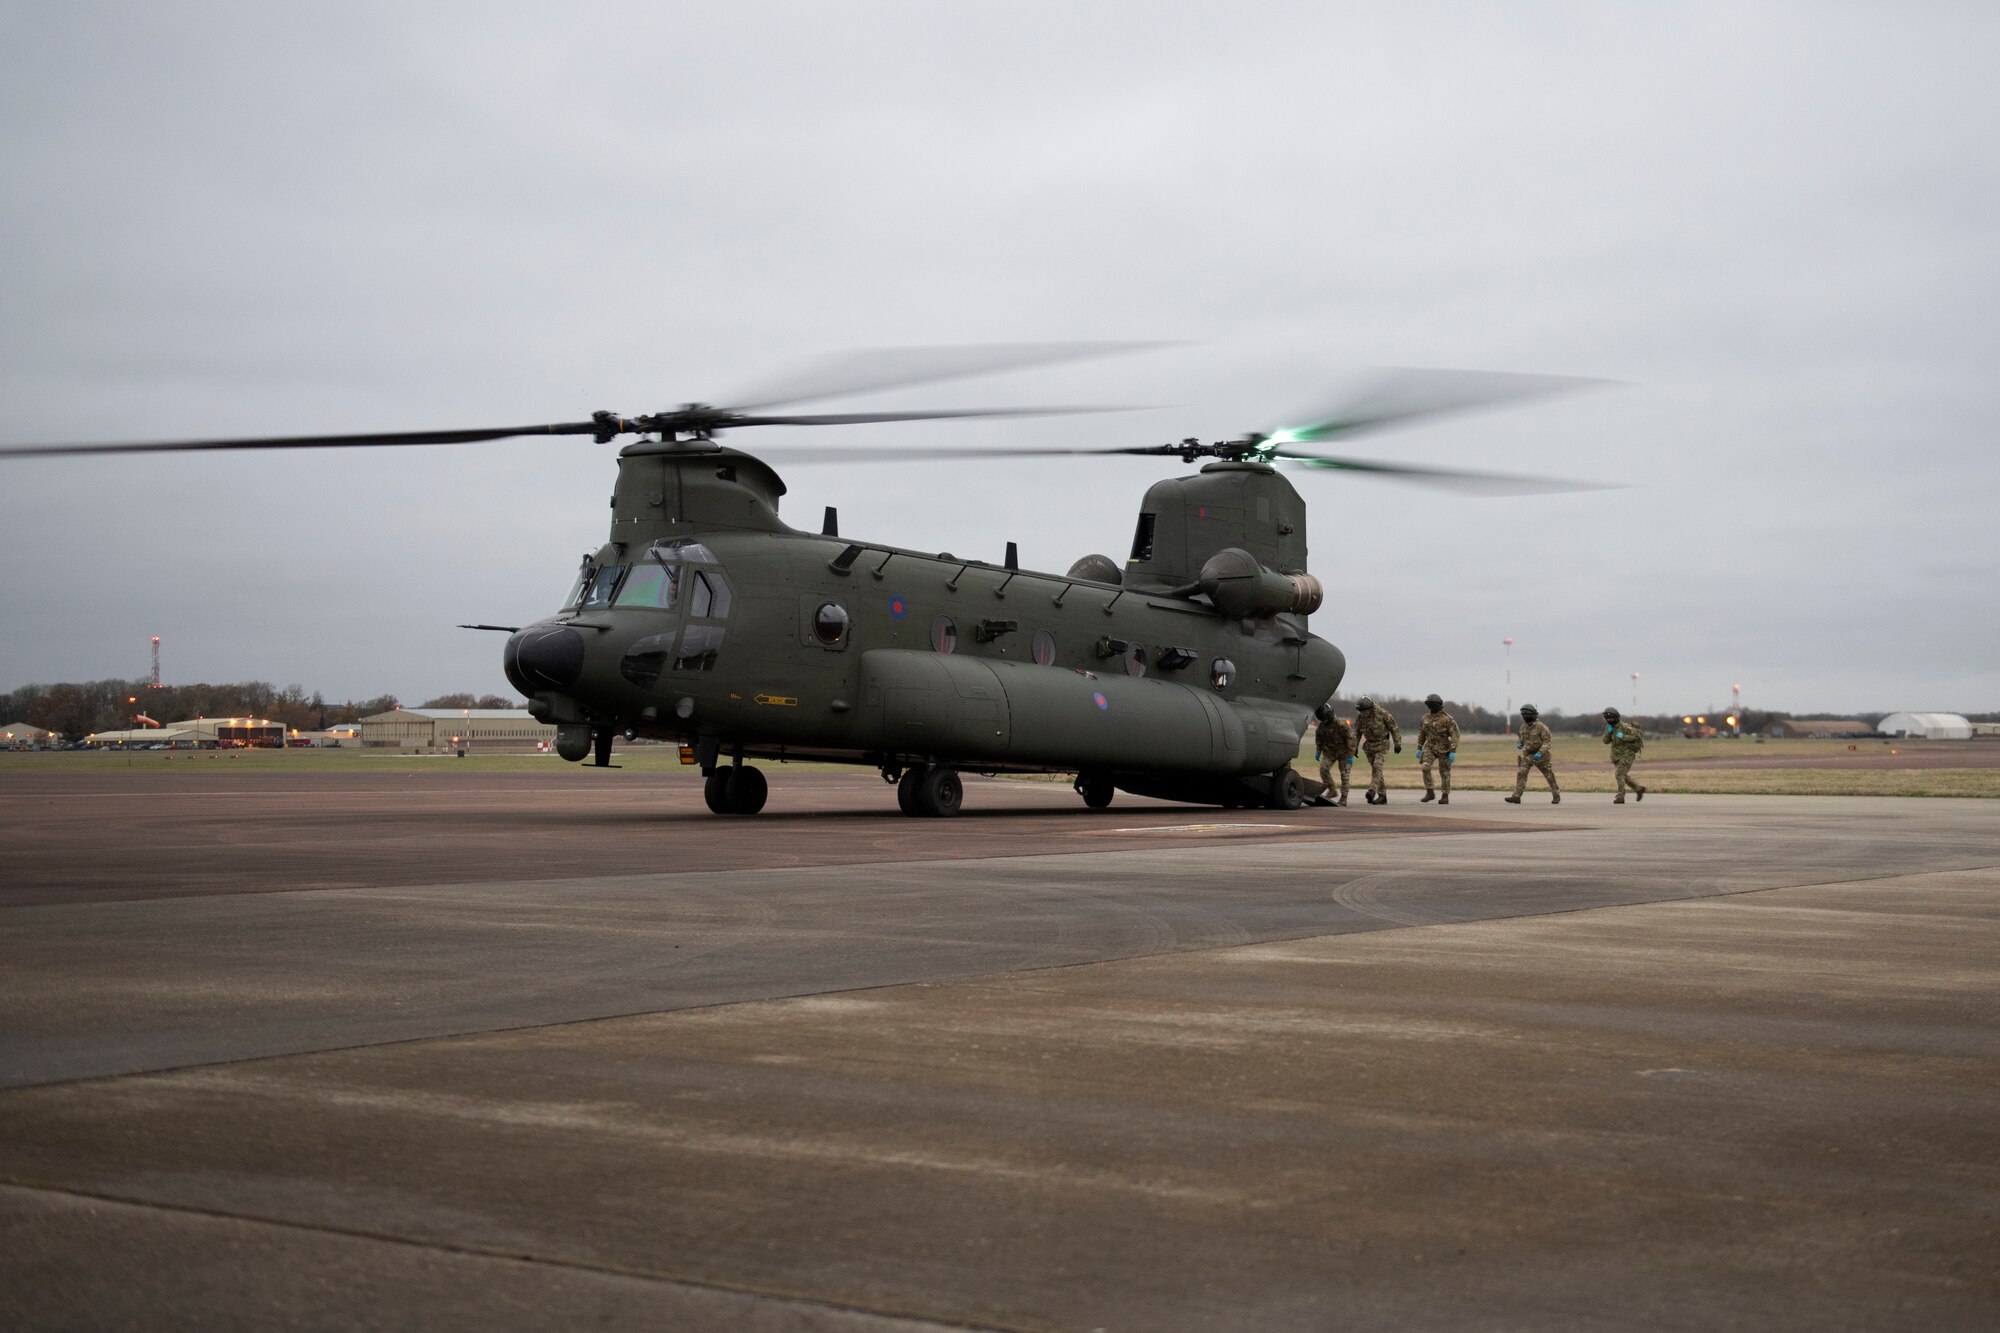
[0, 679, 522, 741]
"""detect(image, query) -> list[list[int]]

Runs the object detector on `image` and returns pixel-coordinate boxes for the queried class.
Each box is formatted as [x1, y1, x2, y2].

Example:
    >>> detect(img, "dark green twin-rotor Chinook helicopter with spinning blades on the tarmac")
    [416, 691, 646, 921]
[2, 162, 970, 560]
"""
[0, 344, 1586, 815]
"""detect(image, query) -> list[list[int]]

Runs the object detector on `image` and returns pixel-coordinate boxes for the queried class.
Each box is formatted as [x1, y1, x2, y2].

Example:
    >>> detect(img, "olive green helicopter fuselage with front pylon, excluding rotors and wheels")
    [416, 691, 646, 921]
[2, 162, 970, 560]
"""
[506, 442, 1346, 799]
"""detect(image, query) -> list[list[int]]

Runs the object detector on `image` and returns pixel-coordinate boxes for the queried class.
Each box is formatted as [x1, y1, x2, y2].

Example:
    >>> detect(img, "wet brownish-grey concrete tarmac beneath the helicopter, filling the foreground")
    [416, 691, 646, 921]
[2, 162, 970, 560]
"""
[0, 771, 2000, 1329]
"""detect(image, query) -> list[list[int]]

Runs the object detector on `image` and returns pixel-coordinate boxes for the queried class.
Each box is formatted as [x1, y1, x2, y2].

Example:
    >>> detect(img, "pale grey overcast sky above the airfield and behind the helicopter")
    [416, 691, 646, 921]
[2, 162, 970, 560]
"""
[0, 0, 2000, 713]
